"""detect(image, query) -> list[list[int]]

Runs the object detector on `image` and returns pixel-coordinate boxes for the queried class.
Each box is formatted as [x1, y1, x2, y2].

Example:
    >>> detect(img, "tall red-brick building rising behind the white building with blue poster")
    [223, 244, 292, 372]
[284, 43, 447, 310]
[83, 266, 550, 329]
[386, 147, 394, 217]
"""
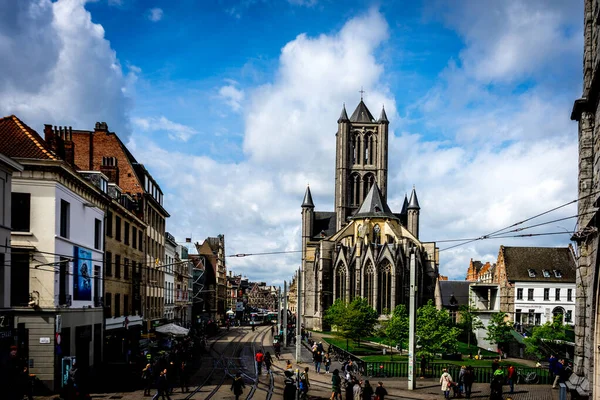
[73, 122, 169, 329]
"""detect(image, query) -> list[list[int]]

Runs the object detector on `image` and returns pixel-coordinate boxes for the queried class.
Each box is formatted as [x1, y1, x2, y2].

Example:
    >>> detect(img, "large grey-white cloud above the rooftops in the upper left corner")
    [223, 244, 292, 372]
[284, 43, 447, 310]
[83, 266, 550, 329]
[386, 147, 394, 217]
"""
[0, 0, 136, 137]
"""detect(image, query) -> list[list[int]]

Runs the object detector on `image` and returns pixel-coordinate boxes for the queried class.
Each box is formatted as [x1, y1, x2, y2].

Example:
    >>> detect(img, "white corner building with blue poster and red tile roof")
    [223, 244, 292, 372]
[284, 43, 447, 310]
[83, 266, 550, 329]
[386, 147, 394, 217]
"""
[0, 116, 109, 389]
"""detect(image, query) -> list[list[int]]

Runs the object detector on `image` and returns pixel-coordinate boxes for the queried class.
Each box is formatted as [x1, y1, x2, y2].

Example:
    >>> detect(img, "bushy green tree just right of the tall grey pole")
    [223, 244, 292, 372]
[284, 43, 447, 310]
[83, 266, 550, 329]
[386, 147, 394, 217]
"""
[417, 300, 460, 358]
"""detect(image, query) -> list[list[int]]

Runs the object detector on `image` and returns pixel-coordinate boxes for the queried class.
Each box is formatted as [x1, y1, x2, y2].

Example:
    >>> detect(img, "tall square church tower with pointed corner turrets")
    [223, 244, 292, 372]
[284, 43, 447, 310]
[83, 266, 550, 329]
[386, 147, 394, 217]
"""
[335, 96, 389, 230]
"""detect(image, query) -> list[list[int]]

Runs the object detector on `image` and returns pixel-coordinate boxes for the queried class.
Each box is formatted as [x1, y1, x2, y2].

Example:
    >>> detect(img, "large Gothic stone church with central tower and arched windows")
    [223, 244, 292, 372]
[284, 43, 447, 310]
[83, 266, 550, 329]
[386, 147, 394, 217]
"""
[302, 99, 438, 330]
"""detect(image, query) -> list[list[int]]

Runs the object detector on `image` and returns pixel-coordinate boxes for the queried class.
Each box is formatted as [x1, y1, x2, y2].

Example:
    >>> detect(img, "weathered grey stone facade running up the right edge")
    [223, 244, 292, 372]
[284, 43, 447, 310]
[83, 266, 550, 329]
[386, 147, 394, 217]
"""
[571, 0, 600, 400]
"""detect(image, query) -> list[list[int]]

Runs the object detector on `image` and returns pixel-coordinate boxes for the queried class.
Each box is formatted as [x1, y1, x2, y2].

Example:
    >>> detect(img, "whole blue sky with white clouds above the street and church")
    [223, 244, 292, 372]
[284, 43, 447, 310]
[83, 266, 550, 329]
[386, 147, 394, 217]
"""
[0, 0, 583, 284]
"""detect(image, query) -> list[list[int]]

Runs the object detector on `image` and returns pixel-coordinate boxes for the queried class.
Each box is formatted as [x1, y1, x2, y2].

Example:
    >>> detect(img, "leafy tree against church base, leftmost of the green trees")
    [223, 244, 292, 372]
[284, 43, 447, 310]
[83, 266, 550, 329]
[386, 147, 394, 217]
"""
[324, 297, 379, 342]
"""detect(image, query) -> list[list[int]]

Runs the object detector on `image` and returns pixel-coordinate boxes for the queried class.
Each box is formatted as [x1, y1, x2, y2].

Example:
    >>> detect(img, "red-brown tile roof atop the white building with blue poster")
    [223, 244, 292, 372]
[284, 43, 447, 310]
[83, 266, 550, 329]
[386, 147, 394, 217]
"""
[0, 115, 58, 160]
